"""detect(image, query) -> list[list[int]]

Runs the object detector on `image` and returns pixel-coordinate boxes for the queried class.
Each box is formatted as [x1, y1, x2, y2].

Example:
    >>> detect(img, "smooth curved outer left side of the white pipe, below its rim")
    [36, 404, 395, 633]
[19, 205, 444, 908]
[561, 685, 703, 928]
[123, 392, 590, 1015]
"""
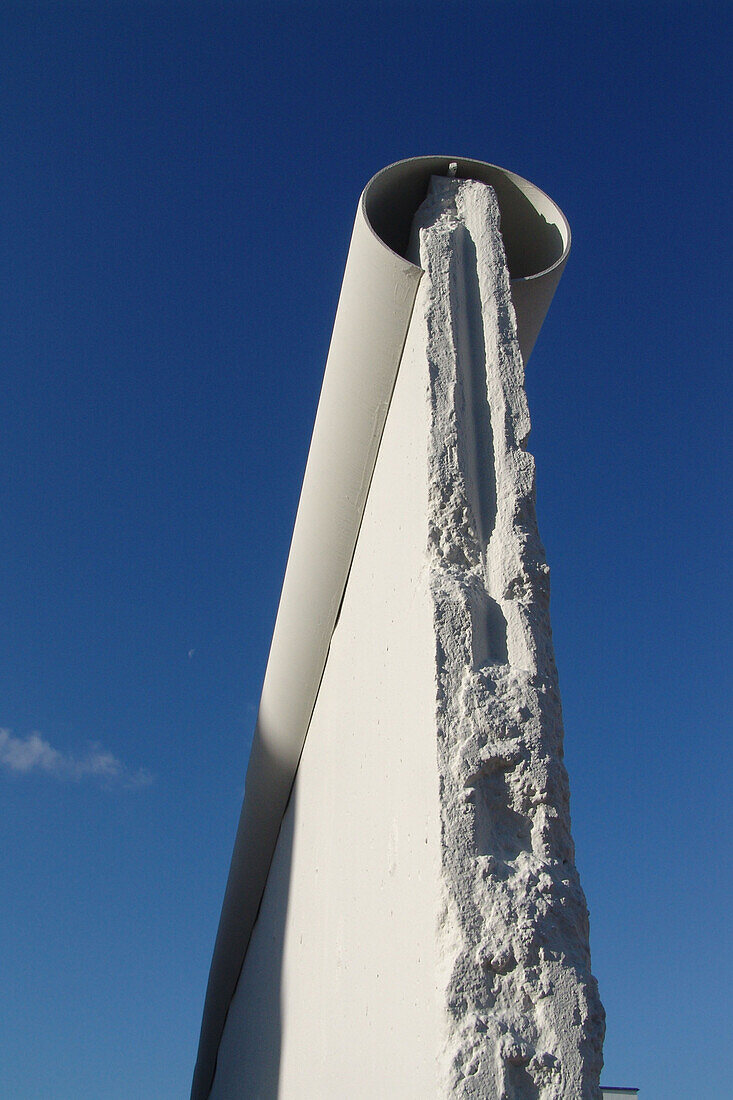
[192, 176, 422, 1100]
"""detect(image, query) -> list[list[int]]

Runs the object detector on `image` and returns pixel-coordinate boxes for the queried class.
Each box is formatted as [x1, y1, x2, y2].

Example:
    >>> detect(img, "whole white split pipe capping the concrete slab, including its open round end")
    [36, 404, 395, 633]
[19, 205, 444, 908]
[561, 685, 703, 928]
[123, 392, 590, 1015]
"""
[192, 156, 570, 1100]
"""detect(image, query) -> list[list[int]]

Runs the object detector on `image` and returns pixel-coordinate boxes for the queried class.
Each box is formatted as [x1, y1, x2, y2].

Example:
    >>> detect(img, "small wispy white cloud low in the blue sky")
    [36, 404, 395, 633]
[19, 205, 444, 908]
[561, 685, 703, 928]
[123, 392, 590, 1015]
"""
[0, 729, 153, 787]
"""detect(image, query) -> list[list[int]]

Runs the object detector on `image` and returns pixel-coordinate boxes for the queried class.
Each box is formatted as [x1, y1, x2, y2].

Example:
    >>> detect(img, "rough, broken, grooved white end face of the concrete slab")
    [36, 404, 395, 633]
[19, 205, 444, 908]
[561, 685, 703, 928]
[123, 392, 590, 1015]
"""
[411, 177, 604, 1100]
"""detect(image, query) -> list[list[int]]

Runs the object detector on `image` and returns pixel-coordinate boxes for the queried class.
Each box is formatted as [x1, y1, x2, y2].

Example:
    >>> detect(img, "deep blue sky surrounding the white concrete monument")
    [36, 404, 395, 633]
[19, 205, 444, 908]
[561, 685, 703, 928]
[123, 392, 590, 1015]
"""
[0, 0, 733, 1100]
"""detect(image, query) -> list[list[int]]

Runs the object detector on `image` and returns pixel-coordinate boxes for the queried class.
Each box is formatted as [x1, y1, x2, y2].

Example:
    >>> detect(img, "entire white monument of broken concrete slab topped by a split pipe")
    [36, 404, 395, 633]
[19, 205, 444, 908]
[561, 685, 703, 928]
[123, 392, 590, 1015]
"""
[193, 157, 604, 1100]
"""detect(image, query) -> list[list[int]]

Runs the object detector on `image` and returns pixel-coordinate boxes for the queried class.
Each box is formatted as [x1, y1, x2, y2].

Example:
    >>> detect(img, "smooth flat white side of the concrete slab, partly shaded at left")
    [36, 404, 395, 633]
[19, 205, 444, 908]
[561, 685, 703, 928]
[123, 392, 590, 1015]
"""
[211, 225, 439, 1100]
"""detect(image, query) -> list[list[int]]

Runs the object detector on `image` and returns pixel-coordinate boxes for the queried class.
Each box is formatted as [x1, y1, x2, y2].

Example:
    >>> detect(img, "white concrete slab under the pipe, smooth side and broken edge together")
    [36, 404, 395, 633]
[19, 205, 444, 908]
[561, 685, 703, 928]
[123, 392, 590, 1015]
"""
[205, 179, 602, 1100]
